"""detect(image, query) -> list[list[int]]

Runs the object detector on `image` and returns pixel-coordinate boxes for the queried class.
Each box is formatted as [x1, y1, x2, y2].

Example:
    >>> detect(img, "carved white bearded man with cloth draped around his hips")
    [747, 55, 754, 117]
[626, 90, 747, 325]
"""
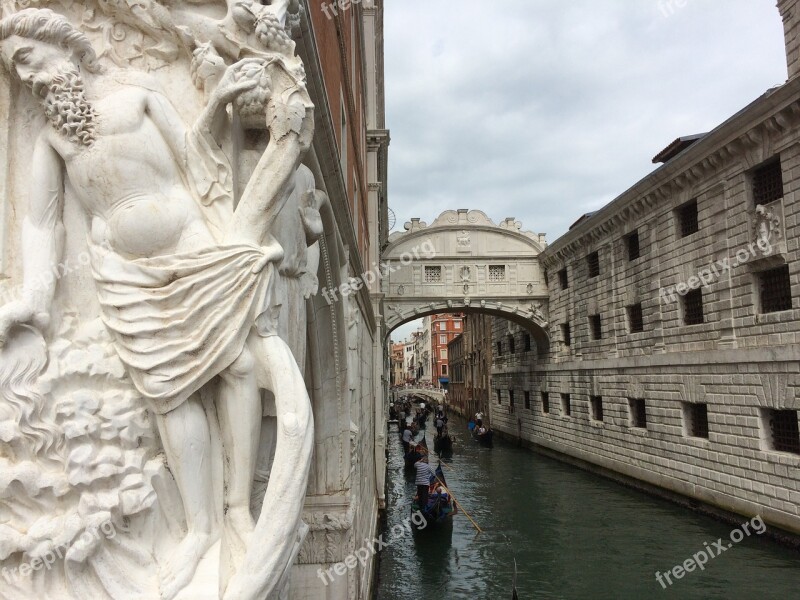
[0, 9, 313, 598]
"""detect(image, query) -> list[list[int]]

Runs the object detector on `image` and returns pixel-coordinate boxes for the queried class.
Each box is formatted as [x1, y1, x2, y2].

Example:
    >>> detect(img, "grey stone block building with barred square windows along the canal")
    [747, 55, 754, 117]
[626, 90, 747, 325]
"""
[491, 0, 800, 533]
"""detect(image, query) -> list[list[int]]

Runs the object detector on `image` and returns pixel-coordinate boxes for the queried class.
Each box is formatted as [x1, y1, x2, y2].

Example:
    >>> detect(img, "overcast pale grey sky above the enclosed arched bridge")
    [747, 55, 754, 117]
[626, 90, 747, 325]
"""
[385, 0, 786, 339]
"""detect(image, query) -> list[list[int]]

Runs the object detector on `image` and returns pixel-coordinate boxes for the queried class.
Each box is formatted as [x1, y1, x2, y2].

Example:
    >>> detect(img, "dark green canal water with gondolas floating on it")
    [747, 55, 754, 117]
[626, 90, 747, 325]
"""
[376, 419, 800, 600]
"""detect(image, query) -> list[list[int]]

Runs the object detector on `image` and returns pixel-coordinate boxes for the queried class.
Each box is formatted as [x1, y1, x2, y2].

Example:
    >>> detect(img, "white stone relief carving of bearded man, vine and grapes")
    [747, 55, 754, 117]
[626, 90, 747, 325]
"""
[0, 0, 320, 600]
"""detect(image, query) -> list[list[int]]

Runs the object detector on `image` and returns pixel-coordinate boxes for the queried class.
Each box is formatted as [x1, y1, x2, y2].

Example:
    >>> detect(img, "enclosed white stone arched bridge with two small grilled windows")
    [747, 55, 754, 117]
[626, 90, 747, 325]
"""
[382, 209, 550, 354]
